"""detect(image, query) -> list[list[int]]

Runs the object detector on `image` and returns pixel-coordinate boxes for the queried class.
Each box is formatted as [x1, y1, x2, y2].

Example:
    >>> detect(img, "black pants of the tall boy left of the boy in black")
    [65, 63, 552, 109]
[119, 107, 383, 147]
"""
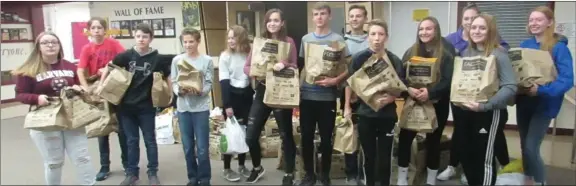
[300, 100, 336, 178]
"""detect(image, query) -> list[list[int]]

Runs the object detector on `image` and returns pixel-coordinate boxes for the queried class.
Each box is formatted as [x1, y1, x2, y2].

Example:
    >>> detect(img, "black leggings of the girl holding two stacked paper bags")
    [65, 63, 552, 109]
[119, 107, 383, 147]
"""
[246, 83, 296, 173]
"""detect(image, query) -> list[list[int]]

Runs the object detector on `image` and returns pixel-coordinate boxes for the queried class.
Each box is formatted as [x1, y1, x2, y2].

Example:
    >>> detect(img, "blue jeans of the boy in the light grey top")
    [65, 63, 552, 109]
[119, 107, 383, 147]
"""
[178, 111, 212, 185]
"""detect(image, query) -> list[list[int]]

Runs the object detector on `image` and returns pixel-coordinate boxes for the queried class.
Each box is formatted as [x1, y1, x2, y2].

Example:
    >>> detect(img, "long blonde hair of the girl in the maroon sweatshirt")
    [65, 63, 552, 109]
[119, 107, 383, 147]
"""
[11, 31, 64, 77]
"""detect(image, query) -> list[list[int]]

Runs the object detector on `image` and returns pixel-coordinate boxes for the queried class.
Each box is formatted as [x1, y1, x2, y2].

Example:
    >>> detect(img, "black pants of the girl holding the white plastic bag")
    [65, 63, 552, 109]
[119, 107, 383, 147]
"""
[222, 87, 254, 169]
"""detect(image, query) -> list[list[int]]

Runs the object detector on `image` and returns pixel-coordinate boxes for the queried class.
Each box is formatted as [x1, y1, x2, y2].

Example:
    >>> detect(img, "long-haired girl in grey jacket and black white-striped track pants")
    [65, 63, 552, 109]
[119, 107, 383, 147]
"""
[460, 14, 517, 185]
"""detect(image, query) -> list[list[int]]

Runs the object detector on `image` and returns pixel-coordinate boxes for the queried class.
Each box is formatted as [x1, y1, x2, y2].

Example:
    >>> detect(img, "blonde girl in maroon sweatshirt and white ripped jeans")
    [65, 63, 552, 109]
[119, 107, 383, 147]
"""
[12, 32, 96, 185]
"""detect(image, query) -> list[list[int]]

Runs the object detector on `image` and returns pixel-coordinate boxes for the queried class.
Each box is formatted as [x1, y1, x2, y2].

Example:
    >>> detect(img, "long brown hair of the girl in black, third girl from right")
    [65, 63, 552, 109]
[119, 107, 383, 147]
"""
[410, 16, 444, 62]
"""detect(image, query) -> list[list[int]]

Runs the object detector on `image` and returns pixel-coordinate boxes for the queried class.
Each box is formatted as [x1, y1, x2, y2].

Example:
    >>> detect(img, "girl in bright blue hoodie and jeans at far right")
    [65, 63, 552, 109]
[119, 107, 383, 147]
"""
[516, 6, 574, 185]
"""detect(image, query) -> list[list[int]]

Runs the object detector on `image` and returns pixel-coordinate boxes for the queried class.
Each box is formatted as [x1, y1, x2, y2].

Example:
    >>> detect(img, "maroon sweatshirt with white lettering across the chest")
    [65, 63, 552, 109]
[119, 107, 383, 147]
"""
[16, 60, 79, 105]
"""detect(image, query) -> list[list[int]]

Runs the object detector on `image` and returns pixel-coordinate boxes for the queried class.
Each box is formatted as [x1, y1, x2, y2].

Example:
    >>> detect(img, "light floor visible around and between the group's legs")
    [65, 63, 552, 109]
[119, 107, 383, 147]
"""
[0, 106, 576, 185]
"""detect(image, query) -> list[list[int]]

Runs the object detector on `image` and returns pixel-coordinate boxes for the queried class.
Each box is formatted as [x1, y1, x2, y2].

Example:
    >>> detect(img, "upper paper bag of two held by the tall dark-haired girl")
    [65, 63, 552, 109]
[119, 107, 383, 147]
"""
[250, 37, 290, 78]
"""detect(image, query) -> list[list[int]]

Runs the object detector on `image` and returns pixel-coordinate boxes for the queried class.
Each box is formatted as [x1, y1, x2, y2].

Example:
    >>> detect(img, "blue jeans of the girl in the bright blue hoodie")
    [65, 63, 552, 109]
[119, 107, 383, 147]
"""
[516, 97, 552, 183]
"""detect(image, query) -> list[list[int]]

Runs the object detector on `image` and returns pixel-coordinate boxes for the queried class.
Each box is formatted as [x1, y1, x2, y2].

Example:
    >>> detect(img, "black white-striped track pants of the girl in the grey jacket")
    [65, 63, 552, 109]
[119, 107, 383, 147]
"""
[459, 110, 502, 185]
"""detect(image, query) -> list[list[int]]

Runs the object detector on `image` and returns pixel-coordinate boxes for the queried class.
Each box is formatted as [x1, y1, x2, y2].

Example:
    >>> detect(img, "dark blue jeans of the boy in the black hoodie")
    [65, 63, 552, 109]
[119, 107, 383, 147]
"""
[117, 108, 158, 176]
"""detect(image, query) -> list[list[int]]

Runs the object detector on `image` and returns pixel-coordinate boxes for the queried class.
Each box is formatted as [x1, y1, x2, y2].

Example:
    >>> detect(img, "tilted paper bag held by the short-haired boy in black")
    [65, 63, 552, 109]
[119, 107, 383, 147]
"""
[347, 54, 407, 111]
